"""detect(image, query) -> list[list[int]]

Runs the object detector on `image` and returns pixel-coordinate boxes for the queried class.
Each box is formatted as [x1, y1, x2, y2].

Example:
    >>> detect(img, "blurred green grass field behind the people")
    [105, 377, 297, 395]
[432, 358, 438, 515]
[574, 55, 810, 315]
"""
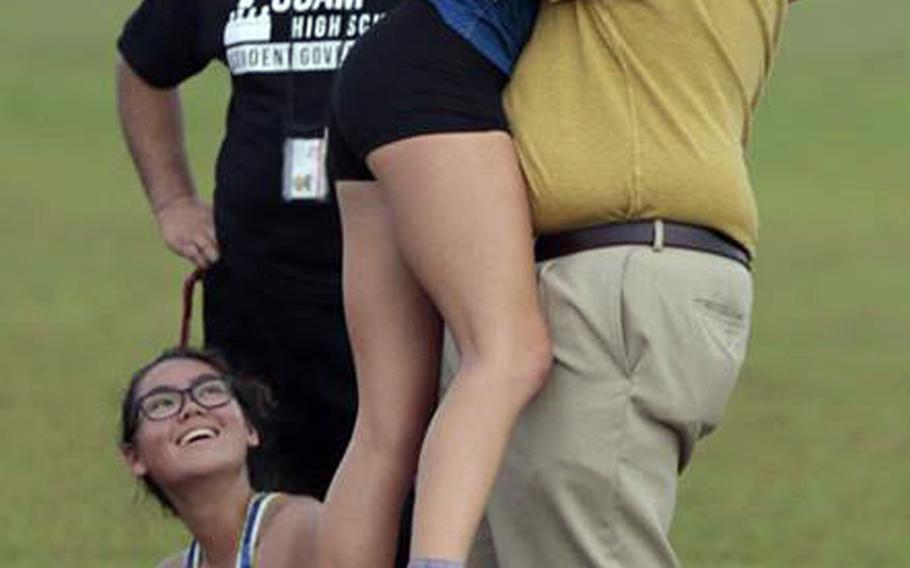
[0, 0, 910, 568]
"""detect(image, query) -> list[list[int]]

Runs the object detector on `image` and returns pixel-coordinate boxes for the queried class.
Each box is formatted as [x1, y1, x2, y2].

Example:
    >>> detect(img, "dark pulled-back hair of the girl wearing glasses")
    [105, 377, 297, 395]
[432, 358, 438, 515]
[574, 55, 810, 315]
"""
[120, 347, 273, 514]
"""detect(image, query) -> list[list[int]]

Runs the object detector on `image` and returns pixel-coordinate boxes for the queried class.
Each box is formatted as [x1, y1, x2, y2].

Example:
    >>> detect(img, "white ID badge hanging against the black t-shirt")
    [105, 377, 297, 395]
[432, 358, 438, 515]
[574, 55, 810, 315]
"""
[281, 129, 329, 202]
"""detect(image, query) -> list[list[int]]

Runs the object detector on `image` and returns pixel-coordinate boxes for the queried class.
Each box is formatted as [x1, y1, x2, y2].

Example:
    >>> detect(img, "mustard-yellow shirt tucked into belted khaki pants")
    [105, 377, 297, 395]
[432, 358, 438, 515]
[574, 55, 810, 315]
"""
[505, 0, 787, 252]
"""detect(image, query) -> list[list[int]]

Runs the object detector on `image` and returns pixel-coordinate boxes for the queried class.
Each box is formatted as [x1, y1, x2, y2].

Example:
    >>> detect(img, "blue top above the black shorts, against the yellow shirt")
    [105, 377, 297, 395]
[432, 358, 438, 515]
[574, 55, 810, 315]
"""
[427, 0, 539, 75]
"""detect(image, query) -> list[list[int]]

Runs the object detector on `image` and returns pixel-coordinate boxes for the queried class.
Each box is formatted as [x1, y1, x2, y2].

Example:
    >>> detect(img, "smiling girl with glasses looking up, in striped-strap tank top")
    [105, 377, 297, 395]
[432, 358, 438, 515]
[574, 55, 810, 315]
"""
[120, 348, 321, 568]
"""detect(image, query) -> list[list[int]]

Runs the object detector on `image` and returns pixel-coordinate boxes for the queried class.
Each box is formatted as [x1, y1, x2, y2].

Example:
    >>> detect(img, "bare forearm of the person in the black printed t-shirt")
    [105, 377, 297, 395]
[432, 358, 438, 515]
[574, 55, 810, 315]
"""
[117, 59, 196, 214]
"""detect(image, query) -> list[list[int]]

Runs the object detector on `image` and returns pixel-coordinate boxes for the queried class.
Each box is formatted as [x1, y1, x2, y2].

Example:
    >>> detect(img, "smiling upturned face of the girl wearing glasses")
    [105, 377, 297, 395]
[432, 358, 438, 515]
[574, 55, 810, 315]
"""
[123, 358, 259, 491]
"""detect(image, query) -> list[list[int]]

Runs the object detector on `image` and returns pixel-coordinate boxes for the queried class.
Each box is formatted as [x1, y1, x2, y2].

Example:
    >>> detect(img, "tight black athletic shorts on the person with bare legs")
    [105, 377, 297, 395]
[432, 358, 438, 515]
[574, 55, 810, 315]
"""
[327, 0, 508, 181]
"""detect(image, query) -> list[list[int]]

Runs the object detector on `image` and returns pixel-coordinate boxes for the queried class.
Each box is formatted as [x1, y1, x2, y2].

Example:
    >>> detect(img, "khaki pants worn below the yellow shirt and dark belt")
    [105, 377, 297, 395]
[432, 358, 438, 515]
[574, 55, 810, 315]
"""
[443, 246, 752, 568]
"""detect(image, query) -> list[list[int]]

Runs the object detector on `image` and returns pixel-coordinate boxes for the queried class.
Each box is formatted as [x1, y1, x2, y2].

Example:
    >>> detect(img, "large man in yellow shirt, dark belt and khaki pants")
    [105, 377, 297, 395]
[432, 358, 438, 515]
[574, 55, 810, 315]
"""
[470, 0, 800, 568]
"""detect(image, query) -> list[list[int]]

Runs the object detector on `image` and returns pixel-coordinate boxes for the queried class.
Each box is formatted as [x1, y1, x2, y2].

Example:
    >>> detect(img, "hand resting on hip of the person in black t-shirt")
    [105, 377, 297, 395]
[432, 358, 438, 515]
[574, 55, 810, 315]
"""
[155, 197, 219, 268]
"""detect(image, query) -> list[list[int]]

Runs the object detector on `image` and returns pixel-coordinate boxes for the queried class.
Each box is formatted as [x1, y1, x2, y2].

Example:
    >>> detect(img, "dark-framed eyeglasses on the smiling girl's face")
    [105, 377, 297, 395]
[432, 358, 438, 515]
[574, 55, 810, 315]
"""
[136, 374, 234, 421]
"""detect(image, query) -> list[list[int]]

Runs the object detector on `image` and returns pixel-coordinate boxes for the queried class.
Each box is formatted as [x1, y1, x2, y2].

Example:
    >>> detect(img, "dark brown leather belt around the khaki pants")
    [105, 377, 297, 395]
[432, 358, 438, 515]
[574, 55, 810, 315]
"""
[534, 221, 752, 268]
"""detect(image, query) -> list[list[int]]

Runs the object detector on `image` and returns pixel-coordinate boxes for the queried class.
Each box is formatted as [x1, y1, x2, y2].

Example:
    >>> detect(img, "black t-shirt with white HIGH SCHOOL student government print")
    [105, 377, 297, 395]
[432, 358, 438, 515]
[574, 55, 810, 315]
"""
[118, 0, 398, 285]
